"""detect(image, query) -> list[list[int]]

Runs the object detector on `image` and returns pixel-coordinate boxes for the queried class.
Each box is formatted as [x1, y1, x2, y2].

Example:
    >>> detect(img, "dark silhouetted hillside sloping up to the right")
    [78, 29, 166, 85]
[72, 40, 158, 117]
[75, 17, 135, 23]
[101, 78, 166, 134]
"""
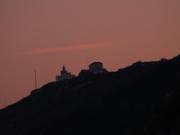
[0, 56, 180, 135]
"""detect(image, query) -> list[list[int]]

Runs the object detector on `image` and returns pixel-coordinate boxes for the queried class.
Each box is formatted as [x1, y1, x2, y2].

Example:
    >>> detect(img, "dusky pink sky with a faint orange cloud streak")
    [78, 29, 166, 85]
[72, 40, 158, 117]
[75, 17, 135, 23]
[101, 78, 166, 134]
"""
[0, 0, 180, 108]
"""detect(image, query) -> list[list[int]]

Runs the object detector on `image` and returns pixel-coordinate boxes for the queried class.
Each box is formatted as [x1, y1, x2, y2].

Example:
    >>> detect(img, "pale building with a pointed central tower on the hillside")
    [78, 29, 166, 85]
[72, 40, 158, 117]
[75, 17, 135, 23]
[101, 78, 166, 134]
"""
[56, 66, 75, 81]
